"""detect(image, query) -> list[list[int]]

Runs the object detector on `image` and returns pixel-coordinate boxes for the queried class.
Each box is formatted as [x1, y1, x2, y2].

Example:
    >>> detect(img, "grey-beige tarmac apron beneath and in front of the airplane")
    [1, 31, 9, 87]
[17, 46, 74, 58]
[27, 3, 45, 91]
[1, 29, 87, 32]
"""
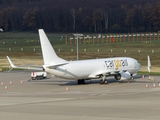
[0, 70, 160, 120]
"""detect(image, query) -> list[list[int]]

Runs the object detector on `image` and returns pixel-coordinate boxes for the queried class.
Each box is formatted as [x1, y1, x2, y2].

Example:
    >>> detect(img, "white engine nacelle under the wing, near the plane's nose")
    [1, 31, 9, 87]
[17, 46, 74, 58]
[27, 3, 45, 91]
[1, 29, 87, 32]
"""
[115, 72, 131, 81]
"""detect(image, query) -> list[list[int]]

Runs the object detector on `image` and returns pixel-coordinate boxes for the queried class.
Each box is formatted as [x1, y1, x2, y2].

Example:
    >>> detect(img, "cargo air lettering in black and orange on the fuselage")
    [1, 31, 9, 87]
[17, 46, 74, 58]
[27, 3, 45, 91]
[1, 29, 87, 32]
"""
[105, 59, 128, 70]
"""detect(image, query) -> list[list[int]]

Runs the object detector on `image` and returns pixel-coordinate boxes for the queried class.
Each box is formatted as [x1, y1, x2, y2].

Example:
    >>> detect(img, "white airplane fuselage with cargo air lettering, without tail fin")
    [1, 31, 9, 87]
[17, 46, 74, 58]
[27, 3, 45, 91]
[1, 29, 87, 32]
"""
[45, 57, 141, 79]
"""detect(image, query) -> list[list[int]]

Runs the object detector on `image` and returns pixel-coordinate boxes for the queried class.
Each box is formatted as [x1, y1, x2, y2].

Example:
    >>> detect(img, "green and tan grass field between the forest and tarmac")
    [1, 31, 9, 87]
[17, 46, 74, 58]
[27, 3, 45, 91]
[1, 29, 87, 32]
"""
[0, 32, 160, 72]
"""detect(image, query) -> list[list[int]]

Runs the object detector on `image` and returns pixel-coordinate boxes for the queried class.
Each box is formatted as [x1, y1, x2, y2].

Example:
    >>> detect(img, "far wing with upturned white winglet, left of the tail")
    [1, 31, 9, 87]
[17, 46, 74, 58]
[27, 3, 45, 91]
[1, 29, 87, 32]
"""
[6, 56, 43, 71]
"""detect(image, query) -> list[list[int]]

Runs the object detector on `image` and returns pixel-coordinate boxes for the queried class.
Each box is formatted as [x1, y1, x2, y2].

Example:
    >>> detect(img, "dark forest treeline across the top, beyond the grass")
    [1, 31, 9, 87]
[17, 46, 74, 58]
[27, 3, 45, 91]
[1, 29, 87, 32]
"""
[0, 0, 160, 33]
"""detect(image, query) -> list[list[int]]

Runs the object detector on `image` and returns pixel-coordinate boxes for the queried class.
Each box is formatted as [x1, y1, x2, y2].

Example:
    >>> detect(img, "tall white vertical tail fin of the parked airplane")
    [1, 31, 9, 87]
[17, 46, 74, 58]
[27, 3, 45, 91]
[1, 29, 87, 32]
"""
[39, 29, 67, 65]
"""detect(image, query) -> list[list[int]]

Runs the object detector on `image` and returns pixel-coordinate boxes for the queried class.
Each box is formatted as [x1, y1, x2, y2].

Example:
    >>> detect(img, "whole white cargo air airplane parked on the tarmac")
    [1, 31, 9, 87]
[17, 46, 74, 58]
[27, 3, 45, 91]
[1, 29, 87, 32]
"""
[7, 29, 142, 84]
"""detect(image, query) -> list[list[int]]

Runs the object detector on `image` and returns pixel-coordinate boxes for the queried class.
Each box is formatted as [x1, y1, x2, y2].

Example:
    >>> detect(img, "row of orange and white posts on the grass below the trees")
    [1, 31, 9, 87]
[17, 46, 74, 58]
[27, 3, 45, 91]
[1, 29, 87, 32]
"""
[65, 32, 160, 45]
